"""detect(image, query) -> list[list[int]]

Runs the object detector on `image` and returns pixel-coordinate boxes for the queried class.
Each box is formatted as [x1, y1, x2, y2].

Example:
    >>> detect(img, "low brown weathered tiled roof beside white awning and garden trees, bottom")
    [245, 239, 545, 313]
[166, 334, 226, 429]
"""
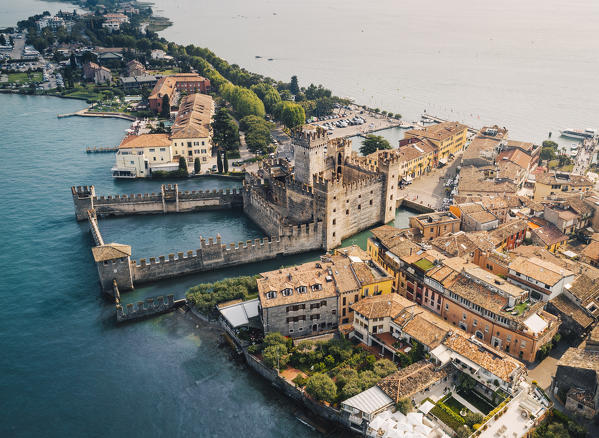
[378, 360, 447, 403]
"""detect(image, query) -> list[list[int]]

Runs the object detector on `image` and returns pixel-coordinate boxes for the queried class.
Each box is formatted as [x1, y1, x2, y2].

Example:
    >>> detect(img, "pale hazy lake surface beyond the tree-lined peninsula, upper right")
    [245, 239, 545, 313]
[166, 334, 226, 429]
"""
[154, 0, 599, 143]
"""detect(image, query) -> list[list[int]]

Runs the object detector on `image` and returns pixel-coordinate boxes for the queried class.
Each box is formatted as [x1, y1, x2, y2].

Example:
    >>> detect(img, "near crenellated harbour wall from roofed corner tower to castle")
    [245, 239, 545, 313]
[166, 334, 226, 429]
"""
[131, 223, 322, 284]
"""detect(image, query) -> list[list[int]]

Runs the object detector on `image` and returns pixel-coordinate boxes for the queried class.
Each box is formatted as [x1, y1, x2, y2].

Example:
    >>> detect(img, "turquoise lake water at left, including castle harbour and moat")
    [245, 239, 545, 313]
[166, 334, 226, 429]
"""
[0, 95, 418, 437]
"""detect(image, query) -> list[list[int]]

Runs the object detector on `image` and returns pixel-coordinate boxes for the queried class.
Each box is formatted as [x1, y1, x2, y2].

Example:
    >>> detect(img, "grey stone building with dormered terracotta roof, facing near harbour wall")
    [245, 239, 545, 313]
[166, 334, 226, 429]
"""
[257, 262, 338, 338]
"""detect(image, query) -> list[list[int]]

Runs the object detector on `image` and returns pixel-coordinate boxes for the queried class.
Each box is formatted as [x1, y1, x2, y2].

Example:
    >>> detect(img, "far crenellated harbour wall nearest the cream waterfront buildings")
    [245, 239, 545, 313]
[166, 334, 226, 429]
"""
[71, 184, 243, 220]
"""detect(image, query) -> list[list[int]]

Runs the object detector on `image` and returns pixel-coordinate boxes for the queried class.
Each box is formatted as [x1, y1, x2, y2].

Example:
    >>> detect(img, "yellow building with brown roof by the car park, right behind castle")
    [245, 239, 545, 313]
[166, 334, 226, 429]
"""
[404, 122, 468, 164]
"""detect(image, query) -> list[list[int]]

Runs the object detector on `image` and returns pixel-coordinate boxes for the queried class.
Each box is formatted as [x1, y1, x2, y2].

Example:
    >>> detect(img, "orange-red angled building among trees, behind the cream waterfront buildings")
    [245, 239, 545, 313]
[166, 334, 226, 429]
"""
[148, 73, 210, 113]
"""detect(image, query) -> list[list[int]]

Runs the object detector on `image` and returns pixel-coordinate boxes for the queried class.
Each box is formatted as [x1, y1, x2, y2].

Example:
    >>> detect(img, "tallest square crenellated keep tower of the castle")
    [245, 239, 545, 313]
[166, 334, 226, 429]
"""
[292, 126, 329, 185]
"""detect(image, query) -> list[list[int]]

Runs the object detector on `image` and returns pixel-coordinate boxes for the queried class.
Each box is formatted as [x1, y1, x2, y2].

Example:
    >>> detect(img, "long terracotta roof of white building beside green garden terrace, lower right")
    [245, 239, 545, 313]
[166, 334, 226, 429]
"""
[443, 333, 524, 382]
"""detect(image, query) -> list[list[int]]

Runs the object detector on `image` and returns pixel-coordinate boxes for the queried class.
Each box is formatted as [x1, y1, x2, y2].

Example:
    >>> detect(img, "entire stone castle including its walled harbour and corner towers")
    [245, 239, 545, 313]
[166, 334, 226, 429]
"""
[71, 127, 399, 293]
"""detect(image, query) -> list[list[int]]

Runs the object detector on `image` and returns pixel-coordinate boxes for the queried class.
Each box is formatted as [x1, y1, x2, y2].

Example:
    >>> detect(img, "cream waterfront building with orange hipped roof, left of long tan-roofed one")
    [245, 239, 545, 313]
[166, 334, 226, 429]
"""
[112, 134, 179, 178]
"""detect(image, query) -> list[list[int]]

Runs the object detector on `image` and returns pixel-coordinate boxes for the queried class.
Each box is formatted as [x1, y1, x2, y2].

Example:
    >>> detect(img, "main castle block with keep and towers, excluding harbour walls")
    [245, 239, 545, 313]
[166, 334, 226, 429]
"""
[243, 127, 399, 250]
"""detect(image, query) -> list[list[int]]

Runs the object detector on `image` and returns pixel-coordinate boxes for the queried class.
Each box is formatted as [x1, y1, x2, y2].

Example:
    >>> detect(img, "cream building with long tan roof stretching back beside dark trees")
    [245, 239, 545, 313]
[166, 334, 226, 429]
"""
[170, 93, 214, 168]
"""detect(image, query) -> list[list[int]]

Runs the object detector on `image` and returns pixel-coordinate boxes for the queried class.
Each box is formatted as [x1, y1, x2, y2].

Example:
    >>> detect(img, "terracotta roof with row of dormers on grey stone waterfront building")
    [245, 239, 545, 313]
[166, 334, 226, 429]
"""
[257, 262, 337, 308]
